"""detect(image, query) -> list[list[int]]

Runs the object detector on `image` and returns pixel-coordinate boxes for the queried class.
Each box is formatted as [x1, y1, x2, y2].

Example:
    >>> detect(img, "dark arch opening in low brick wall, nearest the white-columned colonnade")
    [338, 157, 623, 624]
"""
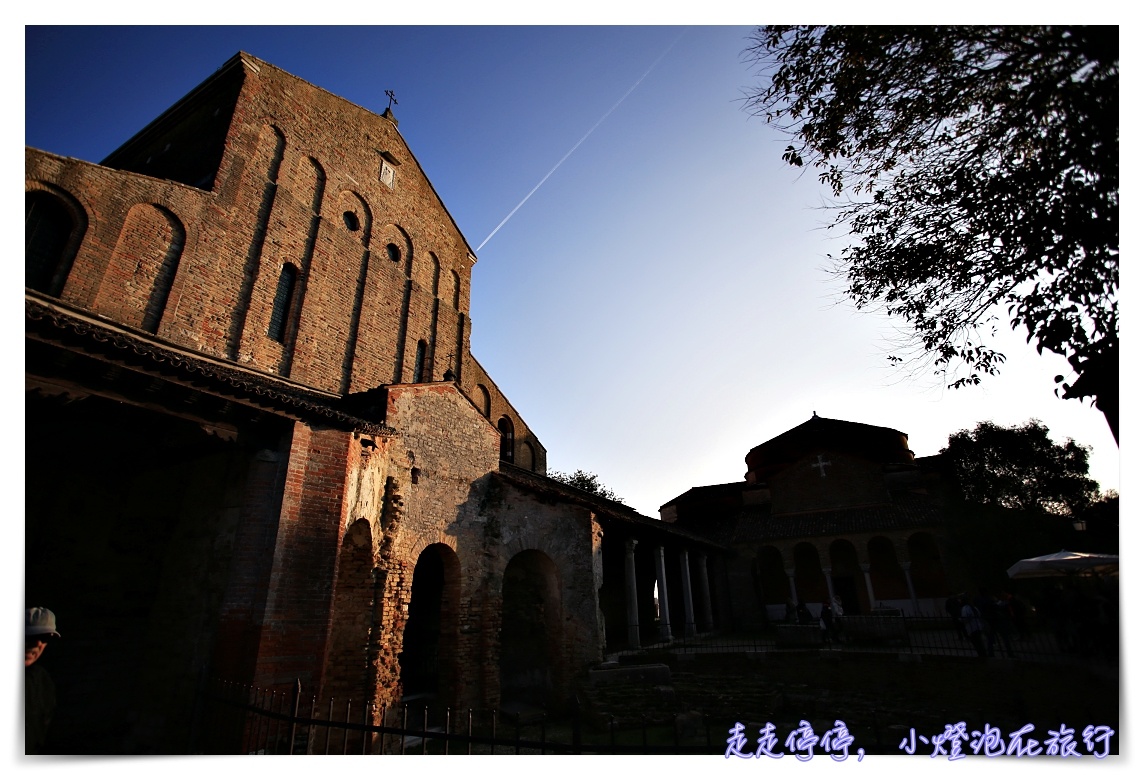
[500, 550, 563, 709]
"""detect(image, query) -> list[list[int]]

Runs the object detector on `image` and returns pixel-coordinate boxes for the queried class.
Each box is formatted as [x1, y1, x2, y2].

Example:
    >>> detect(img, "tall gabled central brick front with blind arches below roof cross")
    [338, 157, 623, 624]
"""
[216, 56, 472, 391]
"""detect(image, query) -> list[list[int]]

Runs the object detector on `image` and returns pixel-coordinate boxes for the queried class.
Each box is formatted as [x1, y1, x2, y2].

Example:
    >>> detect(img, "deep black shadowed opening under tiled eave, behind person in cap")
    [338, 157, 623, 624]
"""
[24, 386, 286, 755]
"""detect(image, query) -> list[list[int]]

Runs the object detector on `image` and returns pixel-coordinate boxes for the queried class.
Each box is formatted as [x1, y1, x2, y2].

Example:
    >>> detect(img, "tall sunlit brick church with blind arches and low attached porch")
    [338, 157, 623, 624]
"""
[24, 54, 730, 754]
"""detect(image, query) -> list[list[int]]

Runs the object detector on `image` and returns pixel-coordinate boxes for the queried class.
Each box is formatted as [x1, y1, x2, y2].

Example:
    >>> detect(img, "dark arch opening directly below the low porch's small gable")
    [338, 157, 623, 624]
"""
[397, 544, 460, 705]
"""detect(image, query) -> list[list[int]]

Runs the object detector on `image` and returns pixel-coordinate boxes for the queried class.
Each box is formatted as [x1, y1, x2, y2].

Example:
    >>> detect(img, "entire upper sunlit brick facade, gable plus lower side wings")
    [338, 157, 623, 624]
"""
[25, 55, 546, 455]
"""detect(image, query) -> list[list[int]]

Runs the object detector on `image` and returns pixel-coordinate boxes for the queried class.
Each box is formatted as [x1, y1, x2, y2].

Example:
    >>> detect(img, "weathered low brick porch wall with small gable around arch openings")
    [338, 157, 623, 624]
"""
[313, 382, 603, 706]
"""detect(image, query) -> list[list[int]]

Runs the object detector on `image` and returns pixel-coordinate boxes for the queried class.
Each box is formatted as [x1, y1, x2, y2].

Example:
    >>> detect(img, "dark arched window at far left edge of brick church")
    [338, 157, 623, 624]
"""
[24, 190, 82, 295]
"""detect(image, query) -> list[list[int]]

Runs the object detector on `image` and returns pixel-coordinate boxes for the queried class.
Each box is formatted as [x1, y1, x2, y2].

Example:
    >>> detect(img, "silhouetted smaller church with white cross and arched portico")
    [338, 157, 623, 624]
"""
[660, 413, 950, 626]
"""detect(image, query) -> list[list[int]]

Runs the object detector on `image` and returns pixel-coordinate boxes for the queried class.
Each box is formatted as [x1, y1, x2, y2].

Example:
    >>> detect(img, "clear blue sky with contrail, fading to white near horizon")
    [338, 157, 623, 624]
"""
[25, 26, 1120, 516]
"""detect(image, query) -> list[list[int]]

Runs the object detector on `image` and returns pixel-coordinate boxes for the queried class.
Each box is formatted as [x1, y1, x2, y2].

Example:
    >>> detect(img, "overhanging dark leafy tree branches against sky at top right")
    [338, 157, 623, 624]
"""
[746, 25, 1120, 436]
